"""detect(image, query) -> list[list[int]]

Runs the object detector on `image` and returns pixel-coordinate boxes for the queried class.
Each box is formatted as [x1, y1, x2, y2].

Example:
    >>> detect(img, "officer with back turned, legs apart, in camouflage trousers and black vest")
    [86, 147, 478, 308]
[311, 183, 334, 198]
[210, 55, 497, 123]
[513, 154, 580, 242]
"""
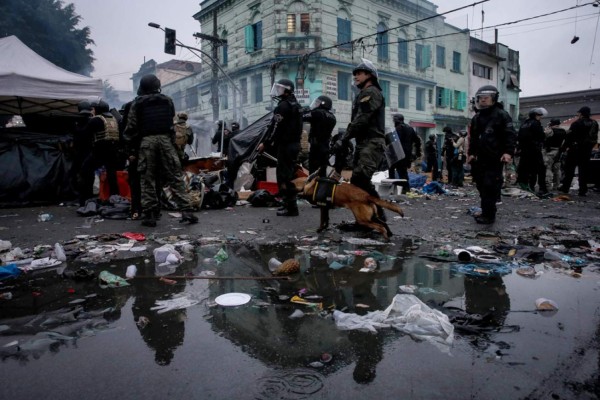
[124, 74, 198, 227]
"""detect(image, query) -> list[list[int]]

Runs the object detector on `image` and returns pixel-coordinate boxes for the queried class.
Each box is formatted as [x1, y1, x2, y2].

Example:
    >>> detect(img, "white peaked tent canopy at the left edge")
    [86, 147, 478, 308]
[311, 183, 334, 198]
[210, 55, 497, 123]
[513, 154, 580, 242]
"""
[0, 36, 102, 115]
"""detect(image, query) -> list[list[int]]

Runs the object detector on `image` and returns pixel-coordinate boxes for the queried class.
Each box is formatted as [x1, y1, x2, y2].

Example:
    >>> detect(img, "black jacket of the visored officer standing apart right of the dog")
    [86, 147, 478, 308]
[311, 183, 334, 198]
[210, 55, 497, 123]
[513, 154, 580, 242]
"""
[469, 103, 517, 163]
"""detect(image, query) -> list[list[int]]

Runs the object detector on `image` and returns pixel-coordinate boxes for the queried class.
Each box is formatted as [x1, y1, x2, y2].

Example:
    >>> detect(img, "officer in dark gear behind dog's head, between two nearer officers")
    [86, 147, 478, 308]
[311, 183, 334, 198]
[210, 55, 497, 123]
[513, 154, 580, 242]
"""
[302, 96, 337, 177]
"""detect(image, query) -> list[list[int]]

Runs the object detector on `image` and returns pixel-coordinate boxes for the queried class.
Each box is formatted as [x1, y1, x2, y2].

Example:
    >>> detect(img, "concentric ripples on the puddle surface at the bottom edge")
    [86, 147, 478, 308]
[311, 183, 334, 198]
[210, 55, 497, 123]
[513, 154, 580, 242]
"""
[255, 370, 323, 400]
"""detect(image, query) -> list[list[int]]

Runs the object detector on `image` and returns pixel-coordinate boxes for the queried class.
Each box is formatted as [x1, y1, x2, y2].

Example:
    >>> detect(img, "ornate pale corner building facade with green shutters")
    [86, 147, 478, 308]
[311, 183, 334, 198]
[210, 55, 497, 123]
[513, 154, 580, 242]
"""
[163, 0, 518, 142]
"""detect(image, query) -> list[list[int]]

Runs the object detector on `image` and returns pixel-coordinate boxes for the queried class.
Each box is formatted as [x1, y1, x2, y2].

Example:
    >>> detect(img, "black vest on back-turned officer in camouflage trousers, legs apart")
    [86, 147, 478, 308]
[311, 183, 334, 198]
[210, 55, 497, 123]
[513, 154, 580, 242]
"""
[136, 94, 173, 136]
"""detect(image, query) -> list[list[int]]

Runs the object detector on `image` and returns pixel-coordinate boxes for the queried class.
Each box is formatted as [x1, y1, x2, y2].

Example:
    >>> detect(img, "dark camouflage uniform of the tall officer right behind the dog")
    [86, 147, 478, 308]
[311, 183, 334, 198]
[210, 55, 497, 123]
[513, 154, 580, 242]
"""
[345, 85, 386, 197]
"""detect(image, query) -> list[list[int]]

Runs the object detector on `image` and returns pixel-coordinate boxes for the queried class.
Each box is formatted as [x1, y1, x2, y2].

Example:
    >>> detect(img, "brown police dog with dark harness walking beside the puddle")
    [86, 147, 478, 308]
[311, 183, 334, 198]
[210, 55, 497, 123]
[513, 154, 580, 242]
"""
[297, 173, 404, 240]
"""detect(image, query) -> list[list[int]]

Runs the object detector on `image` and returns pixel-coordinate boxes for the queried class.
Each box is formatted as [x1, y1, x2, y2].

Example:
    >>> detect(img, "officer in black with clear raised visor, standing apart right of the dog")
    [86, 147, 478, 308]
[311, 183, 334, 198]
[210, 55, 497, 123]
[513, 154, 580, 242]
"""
[468, 85, 517, 224]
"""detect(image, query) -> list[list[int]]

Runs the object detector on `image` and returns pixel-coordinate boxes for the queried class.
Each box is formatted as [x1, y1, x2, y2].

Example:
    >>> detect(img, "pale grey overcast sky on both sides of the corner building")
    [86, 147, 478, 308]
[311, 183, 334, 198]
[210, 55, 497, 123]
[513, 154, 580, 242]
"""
[71, 0, 600, 96]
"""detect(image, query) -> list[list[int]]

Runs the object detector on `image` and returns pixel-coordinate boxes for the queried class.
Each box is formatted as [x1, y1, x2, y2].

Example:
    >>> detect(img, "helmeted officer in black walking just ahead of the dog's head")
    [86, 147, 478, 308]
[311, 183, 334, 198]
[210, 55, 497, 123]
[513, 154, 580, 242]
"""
[257, 79, 302, 217]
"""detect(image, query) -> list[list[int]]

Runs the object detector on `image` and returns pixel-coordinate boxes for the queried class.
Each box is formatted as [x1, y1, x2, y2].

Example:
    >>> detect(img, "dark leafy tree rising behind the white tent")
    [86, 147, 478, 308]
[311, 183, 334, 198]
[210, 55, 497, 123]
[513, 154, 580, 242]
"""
[0, 0, 94, 76]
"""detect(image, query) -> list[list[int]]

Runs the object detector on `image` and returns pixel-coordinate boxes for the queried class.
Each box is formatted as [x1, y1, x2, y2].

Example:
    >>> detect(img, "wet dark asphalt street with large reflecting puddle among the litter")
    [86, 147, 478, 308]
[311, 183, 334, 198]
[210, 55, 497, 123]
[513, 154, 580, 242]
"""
[0, 187, 600, 399]
